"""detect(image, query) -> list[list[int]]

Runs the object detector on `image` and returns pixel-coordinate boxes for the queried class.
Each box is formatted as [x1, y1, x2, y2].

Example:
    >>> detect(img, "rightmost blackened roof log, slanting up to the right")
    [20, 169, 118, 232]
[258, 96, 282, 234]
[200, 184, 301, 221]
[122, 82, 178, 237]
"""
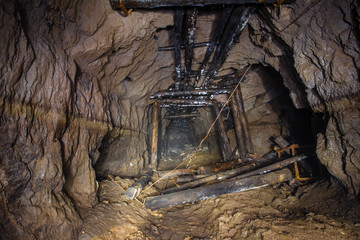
[202, 6, 255, 87]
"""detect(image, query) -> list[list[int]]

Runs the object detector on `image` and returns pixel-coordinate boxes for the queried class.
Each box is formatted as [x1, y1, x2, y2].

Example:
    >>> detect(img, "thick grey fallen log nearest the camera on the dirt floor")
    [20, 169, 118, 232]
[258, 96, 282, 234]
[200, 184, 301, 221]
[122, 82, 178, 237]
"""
[145, 169, 292, 210]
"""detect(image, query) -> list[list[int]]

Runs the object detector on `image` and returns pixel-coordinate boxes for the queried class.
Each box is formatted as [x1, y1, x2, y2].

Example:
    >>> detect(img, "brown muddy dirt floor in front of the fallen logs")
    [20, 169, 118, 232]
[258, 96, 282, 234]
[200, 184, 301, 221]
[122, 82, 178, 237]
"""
[79, 173, 360, 240]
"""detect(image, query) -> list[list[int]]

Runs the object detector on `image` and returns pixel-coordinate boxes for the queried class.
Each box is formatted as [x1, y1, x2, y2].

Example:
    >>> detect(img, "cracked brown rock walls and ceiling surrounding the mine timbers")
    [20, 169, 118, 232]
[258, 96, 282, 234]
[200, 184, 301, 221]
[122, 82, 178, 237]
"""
[0, 0, 360, 239]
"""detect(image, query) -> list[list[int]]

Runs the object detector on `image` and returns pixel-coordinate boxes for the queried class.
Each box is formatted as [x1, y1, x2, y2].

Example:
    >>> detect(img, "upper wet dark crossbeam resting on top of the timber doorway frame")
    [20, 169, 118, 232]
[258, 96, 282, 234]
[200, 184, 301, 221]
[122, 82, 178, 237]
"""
[150, 88, 232, 99]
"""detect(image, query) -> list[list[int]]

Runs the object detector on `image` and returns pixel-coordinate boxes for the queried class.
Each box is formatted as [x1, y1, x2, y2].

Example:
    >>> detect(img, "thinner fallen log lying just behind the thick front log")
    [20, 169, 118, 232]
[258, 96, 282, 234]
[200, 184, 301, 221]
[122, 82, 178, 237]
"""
[162, 155, 306, 194]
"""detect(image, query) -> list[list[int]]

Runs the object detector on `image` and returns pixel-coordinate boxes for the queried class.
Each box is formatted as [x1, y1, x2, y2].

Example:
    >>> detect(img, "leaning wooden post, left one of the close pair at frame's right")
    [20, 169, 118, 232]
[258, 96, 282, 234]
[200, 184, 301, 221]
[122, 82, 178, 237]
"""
[230, 96, 247, 159]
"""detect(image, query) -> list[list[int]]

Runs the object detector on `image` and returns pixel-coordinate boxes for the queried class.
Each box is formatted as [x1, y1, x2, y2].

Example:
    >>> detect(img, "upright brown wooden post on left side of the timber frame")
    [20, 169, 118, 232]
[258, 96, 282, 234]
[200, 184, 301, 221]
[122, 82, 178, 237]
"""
[150, 101, 159, 170]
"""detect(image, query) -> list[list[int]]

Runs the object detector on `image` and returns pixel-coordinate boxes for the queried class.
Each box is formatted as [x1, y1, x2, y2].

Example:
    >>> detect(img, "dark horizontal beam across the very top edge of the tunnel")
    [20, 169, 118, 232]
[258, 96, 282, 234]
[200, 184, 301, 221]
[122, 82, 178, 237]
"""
[110, 0, 294, 10]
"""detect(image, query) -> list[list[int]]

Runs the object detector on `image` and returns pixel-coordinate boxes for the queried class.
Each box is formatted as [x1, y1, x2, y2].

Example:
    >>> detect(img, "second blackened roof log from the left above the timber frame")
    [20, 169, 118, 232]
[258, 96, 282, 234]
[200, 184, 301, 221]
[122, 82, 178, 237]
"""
[184, 8, 198, 88]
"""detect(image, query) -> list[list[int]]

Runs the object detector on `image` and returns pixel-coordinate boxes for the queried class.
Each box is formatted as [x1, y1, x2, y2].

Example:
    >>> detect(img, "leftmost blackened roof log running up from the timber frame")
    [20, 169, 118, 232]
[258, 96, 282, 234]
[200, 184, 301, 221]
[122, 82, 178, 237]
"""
[174, 8, 184, 90]
